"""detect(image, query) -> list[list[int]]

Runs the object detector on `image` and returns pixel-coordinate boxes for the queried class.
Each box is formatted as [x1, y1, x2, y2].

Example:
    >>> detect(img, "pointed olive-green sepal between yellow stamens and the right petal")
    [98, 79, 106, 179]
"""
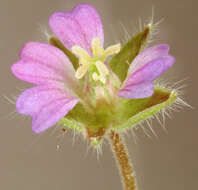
[109, 26, 151, 82]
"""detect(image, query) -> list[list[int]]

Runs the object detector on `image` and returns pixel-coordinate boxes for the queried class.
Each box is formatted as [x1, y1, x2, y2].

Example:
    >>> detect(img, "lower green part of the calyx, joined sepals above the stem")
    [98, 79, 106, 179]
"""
[60, 87, 177, 142]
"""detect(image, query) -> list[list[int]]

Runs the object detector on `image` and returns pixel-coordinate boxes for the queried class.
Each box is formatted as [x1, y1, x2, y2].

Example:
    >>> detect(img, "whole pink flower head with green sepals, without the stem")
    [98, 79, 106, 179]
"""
[11, 4, 177, 145]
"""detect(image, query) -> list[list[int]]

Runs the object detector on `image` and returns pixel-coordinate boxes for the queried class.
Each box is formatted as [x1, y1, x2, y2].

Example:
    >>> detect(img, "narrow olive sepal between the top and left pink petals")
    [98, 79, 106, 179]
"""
[49, 36, 79, 70]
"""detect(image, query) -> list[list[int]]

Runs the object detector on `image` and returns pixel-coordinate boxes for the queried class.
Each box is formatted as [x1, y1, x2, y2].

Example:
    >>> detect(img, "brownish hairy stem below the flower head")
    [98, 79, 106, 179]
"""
[109, 131, 137, 190]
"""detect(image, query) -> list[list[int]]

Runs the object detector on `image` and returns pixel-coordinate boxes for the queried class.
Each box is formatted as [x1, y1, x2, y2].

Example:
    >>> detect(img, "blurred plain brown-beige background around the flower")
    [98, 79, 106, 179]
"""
[0, 0, 198, 190]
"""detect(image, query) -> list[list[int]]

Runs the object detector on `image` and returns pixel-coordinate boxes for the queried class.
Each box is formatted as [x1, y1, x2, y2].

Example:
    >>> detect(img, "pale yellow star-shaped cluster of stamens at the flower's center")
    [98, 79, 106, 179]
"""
[72, 37, 120, 84]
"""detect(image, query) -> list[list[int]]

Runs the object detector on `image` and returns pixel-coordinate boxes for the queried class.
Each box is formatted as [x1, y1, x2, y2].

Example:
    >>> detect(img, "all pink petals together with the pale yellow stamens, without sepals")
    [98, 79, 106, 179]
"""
[11, 4, 174, 133]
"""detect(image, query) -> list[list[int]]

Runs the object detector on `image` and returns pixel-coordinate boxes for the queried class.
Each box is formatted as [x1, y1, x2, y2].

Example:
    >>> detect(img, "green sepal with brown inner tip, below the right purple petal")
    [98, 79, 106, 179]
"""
[112, 88, 177, 130]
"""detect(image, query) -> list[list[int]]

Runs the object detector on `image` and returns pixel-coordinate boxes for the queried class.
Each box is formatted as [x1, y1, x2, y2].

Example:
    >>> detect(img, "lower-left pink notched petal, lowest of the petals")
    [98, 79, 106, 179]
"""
[16, 85, 79, 133]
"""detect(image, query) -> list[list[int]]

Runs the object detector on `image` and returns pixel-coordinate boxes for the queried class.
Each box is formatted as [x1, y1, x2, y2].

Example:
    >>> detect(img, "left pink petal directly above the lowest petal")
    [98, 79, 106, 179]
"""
[11, 42, 75, 84]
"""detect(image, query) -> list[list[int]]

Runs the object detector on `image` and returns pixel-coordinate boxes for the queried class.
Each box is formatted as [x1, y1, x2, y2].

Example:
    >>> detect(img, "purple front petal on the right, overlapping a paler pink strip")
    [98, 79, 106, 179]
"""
[118, 56, 175, 98]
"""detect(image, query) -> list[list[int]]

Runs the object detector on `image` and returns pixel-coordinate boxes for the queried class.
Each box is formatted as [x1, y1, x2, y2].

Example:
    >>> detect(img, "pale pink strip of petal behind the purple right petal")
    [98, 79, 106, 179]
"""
[128, 44, 169, 76]
